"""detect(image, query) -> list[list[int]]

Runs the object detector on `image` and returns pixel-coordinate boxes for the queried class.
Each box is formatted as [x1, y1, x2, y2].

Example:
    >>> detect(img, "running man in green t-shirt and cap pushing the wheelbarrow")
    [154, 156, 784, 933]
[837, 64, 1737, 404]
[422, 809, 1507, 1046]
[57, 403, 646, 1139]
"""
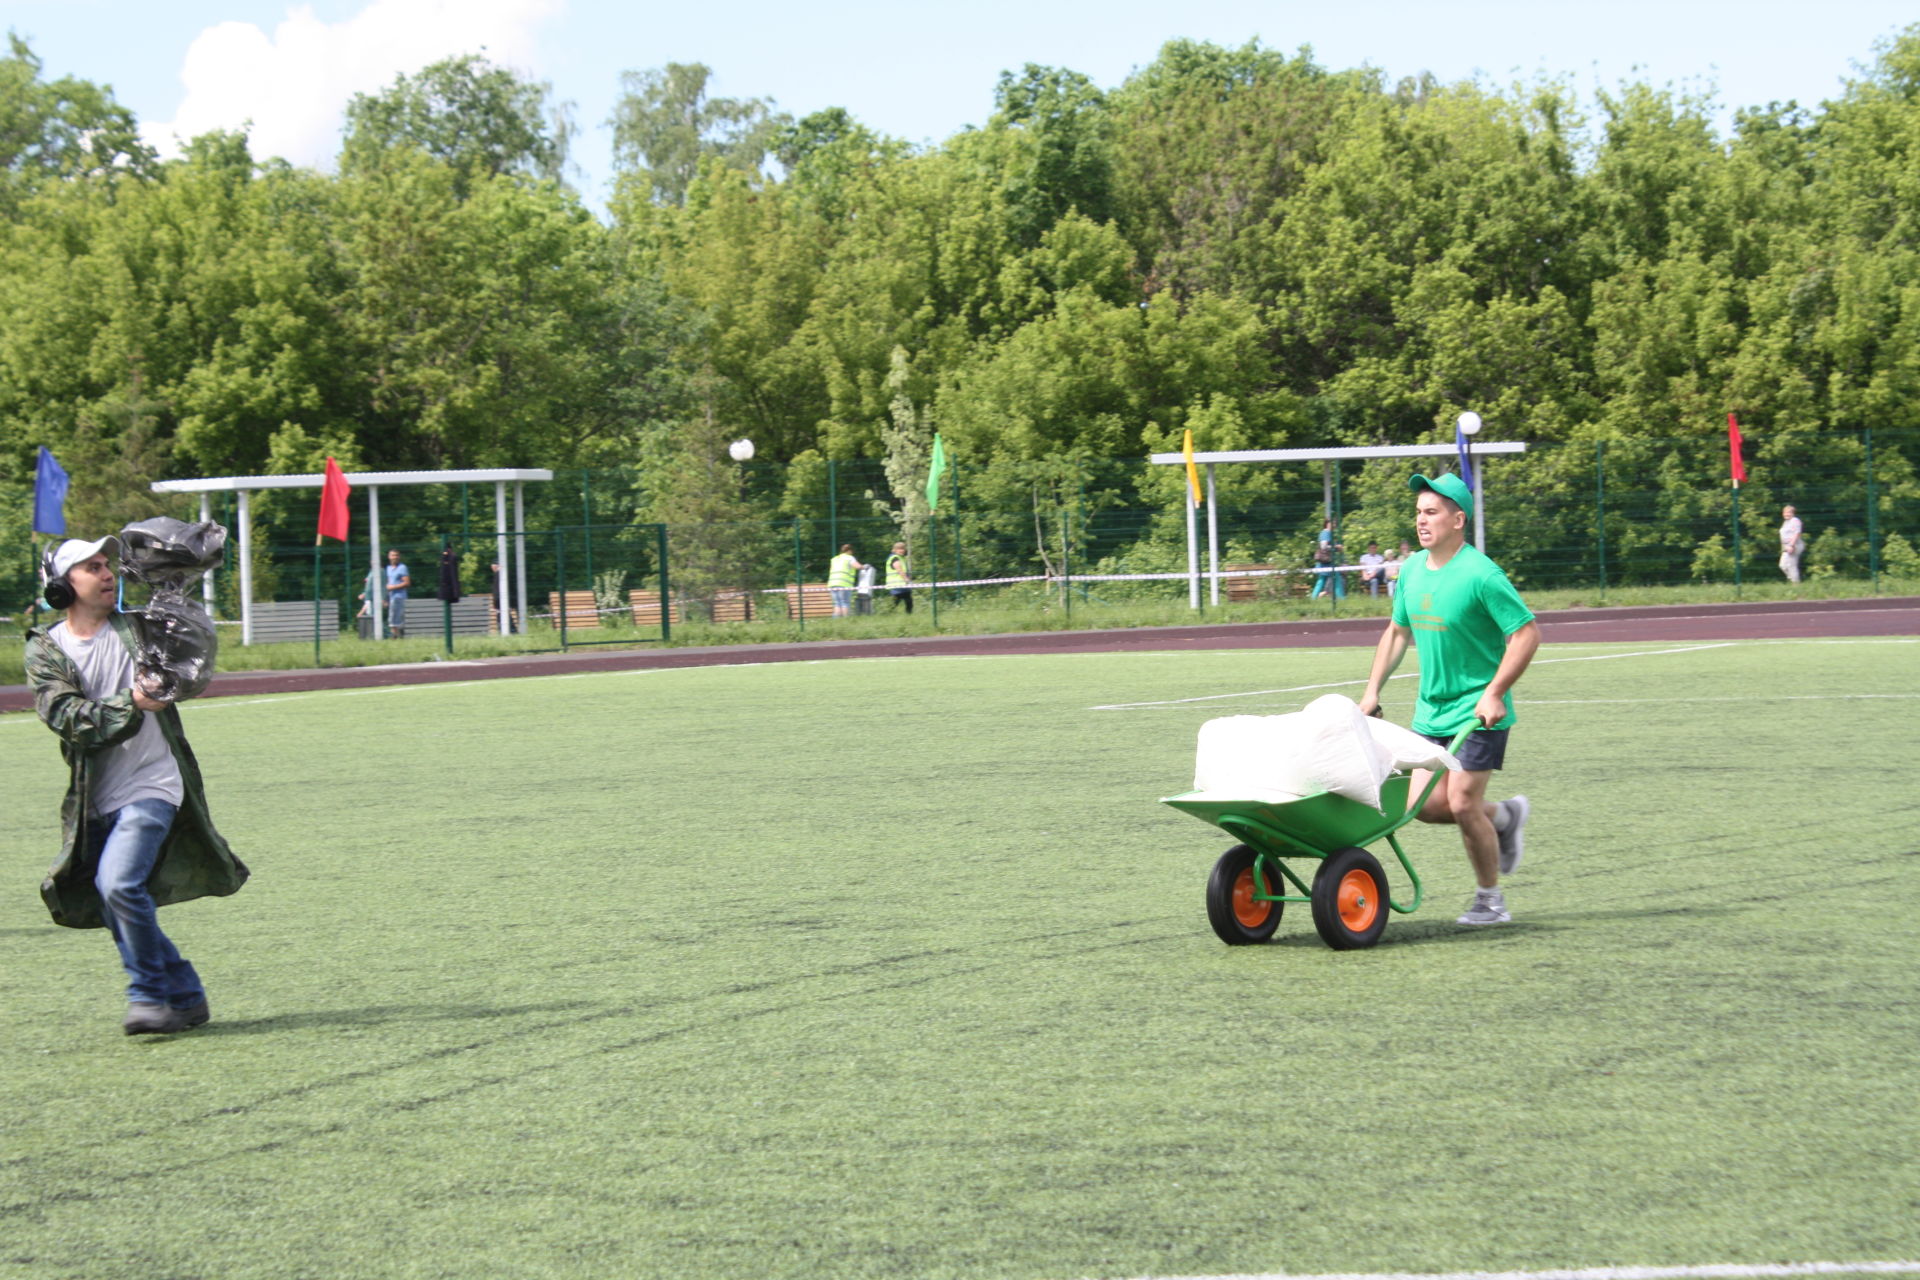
[1359, 476, 1540, 925]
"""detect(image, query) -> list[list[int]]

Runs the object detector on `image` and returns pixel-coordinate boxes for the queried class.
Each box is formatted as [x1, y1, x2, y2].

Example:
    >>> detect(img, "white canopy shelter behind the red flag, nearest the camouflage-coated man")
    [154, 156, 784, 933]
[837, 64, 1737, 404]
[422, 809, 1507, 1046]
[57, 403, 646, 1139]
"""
[152, 470, 553, 645]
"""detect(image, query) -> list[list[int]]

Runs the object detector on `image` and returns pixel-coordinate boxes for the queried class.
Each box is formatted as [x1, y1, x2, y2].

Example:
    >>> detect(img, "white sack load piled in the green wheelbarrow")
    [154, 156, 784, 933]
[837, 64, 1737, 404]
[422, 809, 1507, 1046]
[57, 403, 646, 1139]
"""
[1194, 693, 1459, 808]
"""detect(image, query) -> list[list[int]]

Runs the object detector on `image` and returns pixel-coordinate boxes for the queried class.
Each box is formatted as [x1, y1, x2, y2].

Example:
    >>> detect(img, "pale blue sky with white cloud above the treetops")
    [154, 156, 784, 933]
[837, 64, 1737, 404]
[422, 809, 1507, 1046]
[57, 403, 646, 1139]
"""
[0, 0, 1920, 207]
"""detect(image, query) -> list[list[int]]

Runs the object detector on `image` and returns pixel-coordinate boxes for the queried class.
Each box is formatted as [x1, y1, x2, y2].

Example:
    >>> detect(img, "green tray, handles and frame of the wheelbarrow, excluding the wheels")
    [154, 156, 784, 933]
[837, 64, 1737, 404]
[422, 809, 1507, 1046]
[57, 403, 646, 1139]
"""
[1162, 722, 1480, 940]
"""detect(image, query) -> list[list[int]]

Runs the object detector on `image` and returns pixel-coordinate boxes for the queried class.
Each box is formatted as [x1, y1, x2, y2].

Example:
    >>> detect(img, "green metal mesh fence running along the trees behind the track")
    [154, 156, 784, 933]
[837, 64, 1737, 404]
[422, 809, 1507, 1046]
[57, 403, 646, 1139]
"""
[0, 432, 1920, 647]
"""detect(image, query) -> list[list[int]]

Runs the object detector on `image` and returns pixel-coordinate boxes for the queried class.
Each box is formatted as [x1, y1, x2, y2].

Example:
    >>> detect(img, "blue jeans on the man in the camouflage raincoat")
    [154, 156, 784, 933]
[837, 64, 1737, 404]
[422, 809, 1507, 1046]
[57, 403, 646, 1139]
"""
[88, 800, 207, 1009]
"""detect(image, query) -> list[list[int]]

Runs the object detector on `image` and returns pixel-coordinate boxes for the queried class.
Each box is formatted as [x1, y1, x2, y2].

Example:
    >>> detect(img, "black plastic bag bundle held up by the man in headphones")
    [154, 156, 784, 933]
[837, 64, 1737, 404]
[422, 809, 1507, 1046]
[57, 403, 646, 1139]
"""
[119, 516, 227, 702]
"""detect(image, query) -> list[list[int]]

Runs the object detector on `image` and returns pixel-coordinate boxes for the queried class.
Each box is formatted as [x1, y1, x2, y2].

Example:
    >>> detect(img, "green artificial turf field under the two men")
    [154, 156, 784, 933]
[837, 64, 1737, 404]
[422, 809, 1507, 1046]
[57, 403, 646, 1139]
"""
[0, 641, 1920, 1280]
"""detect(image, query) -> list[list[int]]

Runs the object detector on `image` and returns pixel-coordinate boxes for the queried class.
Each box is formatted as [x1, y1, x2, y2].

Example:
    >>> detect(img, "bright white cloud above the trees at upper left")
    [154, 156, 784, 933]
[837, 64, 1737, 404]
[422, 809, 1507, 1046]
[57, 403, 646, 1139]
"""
[140, 0, 563, 167]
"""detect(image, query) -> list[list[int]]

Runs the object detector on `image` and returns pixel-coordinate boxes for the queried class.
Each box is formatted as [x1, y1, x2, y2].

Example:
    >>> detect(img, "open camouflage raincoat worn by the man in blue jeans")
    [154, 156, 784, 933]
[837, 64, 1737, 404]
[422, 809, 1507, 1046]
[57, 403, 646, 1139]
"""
[27, 614, 248, 929]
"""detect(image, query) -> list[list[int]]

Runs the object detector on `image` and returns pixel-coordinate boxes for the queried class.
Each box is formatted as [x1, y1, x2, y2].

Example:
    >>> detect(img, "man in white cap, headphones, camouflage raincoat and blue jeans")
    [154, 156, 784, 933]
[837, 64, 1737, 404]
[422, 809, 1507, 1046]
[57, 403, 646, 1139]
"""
[25, 537, 248, 1036]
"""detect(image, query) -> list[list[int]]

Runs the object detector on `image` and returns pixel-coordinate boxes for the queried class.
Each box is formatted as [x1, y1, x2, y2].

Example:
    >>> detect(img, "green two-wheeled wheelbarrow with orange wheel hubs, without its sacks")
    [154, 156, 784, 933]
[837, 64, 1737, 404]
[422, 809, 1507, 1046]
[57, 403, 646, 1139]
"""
[1162, 722, 1480, 952]
